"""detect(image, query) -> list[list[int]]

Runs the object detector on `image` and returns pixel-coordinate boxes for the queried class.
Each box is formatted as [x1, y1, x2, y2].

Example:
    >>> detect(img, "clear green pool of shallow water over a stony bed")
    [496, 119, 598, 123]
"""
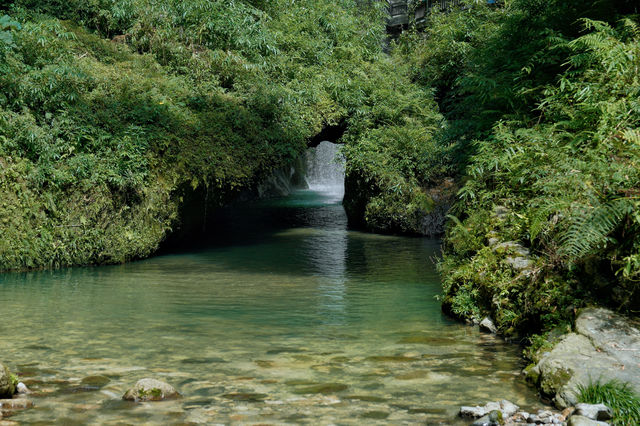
[0, 191, 538, 424]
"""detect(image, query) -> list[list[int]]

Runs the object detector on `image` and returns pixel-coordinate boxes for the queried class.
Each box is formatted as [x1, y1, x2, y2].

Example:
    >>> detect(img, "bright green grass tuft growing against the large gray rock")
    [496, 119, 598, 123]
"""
[578, 380, 640, 425]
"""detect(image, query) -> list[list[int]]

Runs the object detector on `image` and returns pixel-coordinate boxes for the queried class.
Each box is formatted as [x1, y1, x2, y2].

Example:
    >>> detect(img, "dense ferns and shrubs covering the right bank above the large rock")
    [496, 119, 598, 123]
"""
[390, 0, 640, 334]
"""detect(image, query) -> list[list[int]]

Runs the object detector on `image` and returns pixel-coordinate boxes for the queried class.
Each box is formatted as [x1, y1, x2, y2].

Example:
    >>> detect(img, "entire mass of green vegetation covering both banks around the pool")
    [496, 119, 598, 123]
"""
[0, 0, 640, 350]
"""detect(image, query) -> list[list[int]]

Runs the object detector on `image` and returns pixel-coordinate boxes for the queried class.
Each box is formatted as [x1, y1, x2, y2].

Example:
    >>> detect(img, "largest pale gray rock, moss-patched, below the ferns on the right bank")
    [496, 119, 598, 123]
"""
[526, 309, 640, 408]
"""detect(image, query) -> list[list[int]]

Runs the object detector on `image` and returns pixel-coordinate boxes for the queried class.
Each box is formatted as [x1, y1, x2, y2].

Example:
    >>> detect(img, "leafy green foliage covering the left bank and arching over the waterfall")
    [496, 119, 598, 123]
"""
[0, 0, 440, 270]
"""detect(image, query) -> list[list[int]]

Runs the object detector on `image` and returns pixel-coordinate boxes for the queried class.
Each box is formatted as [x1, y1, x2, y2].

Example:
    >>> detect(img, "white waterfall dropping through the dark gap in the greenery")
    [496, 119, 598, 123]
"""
[306, 141, 344, 197]
